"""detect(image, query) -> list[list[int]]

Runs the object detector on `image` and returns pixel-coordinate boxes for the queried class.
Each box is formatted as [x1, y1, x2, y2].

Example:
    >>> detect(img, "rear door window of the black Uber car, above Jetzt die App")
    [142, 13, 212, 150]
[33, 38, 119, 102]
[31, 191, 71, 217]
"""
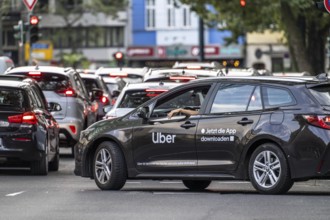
[210, 84, 255, 114]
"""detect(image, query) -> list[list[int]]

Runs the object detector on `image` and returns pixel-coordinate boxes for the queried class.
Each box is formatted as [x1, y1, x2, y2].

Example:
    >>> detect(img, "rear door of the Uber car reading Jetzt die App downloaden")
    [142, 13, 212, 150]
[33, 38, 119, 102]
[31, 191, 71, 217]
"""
[196, 83, 262, 172]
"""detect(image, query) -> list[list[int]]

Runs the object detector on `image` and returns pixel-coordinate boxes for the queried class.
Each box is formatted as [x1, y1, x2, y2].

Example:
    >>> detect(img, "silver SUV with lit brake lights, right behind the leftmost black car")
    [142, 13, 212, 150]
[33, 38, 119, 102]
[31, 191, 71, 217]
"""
[5, 66, 97, 153]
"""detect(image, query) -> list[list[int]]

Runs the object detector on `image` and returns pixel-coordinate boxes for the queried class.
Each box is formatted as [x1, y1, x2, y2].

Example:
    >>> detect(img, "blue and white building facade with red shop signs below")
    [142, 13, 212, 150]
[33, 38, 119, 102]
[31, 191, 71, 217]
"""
[126, 0, 245, 66]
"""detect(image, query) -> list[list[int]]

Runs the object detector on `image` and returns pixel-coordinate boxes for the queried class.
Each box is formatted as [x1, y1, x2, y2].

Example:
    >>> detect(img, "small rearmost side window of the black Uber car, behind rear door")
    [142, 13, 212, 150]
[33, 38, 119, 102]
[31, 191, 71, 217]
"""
[262, 86, 296, 108]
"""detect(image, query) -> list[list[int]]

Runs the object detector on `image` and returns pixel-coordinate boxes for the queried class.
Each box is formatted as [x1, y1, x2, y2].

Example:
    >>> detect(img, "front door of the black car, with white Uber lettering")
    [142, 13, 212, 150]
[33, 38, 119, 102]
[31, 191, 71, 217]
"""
[132, 86, 209, 173]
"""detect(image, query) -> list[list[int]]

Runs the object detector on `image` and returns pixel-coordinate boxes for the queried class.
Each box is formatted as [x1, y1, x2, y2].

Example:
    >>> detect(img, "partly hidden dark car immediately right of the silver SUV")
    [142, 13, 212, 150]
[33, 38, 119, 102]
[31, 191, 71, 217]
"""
[79, 73, 112, 120]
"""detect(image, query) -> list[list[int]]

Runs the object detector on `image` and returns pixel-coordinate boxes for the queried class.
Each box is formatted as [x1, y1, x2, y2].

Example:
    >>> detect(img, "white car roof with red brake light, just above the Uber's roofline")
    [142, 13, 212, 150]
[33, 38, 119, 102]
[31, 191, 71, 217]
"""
[143, 68, 223, 82]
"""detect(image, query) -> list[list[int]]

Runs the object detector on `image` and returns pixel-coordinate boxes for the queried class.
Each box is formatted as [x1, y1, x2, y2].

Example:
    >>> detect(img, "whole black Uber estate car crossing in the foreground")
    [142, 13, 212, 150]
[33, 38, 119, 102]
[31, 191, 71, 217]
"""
[75, 75, 330, 194]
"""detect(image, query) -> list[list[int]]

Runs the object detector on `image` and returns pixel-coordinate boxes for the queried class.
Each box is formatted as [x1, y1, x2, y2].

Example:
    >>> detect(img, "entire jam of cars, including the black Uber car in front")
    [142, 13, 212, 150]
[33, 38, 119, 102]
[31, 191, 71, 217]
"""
[0, 62, 330, 194]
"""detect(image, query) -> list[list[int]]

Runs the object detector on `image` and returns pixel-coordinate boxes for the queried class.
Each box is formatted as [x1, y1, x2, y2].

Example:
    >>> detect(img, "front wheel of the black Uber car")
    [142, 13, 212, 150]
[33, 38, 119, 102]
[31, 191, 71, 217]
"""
[93, 141, 127, 190]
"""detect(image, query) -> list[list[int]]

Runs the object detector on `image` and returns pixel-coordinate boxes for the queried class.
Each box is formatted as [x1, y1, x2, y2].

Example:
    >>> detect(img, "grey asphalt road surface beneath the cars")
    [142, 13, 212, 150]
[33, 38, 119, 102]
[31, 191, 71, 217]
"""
[0, 149, 330, 220]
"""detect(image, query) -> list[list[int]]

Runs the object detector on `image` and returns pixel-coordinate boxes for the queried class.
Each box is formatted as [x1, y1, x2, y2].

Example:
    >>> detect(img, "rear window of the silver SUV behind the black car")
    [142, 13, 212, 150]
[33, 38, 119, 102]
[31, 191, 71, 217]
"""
[15, 71, 72, 91]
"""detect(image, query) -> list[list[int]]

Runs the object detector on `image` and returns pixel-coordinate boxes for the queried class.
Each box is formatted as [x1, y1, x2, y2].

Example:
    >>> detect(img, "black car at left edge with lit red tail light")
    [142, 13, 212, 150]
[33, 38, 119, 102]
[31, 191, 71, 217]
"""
[0, 75, 61, 175]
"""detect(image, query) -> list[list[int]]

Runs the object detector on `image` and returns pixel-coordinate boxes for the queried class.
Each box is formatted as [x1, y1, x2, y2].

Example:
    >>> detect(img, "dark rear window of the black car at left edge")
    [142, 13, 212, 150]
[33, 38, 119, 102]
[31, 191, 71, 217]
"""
[0, 87, 28, 111]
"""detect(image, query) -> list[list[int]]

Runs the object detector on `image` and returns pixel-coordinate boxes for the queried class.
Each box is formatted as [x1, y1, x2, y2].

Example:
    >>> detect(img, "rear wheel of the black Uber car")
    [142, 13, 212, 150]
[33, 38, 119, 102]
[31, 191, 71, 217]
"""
[249, 143, 294, 194]
